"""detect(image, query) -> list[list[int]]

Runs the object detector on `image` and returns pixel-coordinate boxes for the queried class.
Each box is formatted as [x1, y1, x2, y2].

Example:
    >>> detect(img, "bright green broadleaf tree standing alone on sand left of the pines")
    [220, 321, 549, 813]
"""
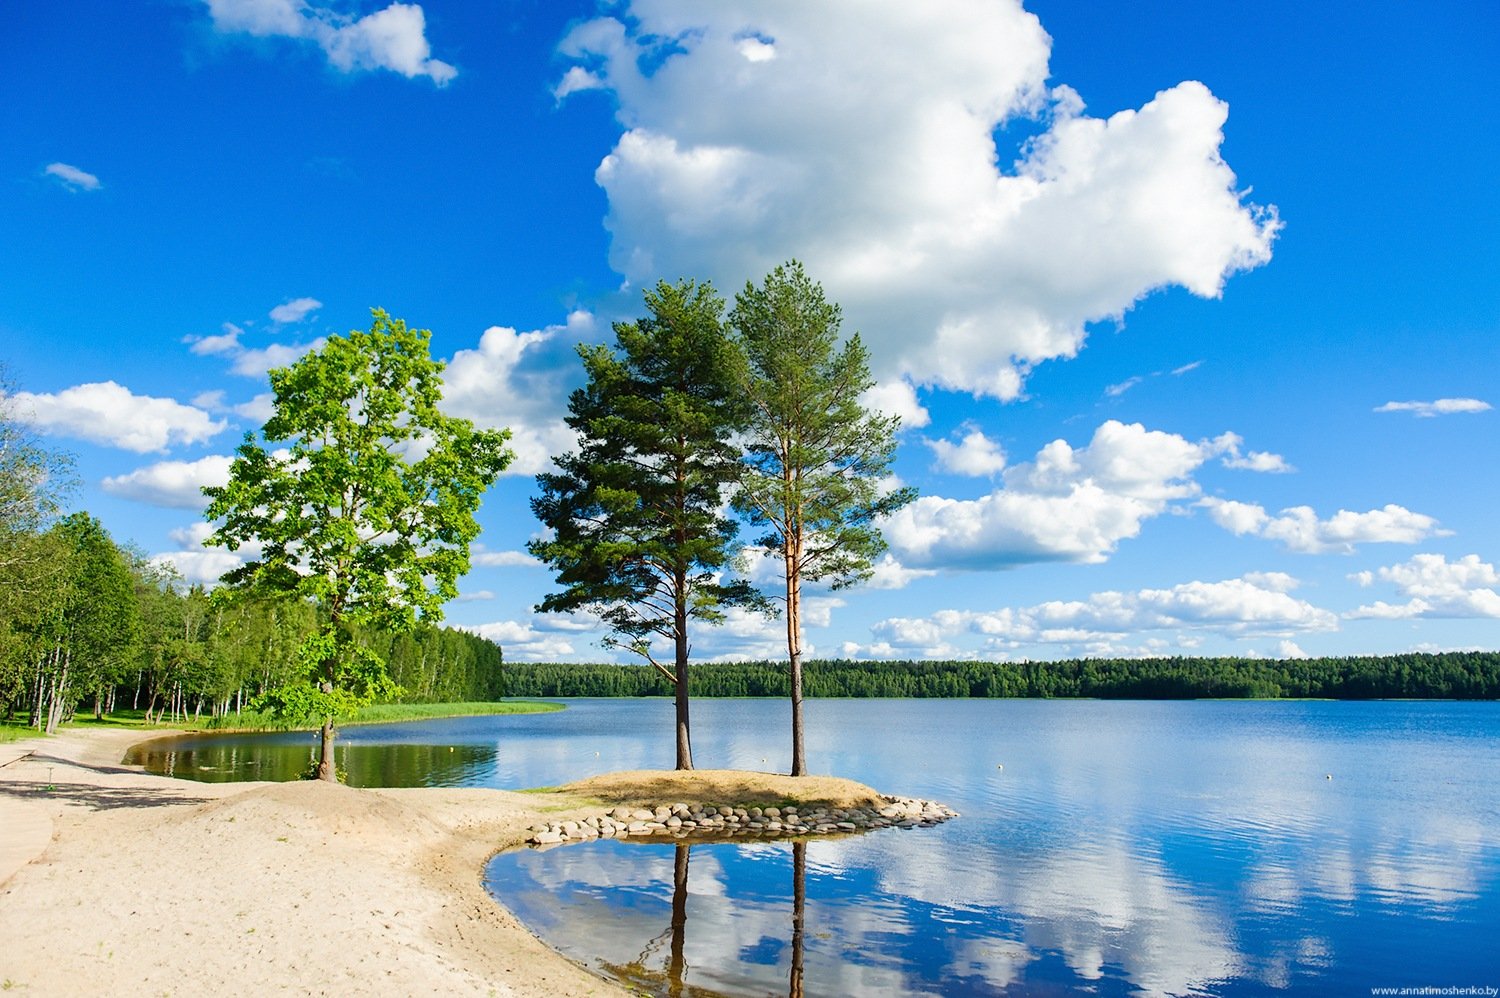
[204, 309, 512, 780]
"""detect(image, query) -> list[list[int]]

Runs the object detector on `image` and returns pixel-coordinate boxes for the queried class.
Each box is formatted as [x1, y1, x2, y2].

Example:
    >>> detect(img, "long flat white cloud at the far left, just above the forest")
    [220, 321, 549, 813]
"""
[8, 381, 228, 453]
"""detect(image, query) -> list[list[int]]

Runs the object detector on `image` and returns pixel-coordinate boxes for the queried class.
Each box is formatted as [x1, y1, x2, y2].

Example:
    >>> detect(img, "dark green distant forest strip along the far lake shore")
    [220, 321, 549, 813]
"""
[504, 651, 1500, 699]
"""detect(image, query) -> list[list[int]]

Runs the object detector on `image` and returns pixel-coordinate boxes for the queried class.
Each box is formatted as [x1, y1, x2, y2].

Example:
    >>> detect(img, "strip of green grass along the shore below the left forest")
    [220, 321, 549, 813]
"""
[0, 699, 563, 743]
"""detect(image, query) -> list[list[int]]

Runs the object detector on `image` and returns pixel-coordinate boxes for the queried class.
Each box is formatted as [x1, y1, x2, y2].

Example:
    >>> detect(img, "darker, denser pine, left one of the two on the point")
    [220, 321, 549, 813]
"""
[531, 281, 764, 770]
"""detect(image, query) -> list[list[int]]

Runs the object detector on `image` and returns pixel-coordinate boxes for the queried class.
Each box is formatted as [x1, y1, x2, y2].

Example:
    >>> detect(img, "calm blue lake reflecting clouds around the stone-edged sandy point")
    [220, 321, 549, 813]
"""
[129, 699, 1500, 995]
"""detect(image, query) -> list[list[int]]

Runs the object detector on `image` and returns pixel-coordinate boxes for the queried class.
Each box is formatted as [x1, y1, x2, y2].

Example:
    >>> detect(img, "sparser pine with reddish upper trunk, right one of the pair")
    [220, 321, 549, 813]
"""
[729, 260, 917, 776]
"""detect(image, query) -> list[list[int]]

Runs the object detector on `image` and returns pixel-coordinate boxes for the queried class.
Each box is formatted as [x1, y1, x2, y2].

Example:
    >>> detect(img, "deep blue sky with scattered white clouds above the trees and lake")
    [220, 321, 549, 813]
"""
[0, 0, 1500, 660]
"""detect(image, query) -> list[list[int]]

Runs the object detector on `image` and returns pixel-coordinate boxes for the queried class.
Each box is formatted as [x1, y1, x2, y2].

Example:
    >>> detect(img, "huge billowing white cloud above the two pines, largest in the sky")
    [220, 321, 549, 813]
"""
[557, 0, 1280, 399]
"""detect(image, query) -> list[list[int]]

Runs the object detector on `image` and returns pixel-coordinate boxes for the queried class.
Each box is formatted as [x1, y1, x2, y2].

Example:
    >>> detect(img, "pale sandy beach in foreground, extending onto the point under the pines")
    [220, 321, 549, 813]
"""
[0, 731, 875, 996]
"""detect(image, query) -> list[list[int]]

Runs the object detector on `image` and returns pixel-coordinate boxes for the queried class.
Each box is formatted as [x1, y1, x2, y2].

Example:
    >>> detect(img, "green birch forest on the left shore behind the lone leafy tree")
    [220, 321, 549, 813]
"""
[0, 393, 503, 732]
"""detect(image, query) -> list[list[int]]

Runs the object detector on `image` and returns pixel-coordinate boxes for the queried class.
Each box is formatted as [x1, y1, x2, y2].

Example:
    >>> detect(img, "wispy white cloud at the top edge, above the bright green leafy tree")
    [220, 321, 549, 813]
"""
[204, 0, 458, 87]
